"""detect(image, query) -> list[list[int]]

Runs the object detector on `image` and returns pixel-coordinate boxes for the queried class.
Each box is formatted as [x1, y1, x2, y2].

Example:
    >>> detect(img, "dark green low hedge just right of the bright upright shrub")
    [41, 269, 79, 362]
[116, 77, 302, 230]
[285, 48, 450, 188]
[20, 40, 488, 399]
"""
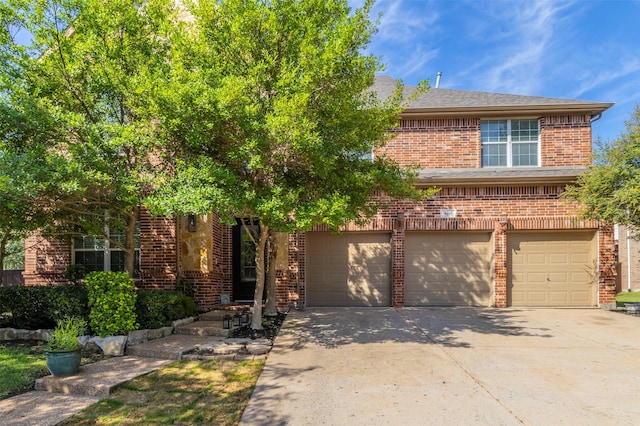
[136, 290, 196, 329]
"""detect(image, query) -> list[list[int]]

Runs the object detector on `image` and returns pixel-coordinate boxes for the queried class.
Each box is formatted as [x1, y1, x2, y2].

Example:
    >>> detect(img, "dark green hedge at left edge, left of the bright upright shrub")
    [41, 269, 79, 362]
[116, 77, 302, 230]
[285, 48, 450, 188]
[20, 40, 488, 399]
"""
[0, 285, 89, 329]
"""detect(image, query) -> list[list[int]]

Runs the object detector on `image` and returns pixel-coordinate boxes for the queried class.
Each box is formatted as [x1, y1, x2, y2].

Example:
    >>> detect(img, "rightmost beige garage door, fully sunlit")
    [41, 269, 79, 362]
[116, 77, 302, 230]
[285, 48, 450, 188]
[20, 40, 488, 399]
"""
[507, 231, 596, 306]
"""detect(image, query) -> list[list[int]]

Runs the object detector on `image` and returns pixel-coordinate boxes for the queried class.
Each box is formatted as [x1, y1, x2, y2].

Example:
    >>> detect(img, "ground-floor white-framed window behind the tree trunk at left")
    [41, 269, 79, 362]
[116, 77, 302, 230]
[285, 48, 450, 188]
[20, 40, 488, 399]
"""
[73, 223, 140, 278]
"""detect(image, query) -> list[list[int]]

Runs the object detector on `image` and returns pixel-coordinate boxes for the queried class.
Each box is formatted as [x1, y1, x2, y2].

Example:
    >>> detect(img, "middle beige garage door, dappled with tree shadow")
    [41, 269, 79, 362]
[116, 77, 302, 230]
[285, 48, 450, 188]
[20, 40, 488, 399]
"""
[405, 231, 493, 306]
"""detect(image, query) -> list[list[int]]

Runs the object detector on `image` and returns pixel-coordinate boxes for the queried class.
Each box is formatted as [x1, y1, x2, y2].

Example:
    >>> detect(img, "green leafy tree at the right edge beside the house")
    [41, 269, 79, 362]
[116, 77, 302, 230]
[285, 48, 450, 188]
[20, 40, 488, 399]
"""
[565, 106, 640, 230]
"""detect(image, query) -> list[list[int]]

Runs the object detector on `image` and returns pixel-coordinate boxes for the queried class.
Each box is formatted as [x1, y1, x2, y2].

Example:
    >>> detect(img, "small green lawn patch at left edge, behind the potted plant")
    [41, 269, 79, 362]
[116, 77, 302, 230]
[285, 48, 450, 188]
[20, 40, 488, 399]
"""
[0, 343, 48, 398]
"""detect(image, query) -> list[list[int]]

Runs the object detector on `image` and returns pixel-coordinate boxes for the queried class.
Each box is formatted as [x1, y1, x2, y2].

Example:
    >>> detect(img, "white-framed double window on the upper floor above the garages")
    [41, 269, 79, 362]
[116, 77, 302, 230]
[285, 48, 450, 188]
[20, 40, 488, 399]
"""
[480, 119, 540, 167]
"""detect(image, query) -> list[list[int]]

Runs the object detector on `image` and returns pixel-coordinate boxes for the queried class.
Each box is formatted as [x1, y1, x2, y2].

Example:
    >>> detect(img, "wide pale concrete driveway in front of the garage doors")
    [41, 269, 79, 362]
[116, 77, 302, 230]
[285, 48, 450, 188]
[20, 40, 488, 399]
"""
[241, 308, 640, 425]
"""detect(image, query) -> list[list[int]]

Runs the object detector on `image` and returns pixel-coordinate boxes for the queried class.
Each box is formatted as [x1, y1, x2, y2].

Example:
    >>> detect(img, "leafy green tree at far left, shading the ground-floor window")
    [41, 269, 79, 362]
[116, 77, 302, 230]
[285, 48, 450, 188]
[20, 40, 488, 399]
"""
[0, 0, 178, 274]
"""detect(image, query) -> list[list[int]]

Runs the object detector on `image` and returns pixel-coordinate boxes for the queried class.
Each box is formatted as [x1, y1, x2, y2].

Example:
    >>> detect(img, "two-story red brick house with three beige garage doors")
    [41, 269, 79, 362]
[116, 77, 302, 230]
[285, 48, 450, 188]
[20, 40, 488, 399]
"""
[24, 76, 616, 310]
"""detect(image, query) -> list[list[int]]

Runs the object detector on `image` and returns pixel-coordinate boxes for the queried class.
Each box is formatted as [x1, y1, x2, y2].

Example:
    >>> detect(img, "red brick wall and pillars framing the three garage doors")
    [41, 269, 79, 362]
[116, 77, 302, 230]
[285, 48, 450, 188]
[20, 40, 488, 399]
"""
[288, 185, 616, 307]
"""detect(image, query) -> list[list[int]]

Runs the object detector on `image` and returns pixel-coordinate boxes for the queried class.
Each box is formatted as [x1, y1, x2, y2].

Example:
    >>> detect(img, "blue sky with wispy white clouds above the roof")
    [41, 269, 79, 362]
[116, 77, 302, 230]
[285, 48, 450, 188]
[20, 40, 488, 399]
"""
[349, 0, 640, 141]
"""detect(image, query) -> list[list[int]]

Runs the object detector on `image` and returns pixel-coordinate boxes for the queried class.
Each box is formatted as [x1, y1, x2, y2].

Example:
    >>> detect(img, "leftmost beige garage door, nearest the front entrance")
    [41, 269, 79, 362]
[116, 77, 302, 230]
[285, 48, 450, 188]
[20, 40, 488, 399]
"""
[306, 232, 391, 306]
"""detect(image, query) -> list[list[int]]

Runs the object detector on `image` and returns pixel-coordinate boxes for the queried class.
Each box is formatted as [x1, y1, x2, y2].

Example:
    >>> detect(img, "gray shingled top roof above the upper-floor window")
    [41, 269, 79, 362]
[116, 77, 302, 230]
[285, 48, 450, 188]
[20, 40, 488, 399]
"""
[372, 75, 613, 113]
